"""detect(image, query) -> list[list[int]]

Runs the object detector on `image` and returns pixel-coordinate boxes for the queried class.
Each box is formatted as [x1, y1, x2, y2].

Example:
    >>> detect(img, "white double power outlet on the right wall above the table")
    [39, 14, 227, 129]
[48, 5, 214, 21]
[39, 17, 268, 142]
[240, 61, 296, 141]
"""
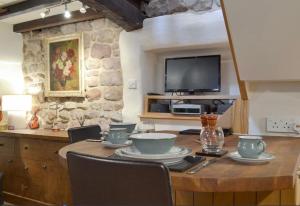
[267, 117, 296, 133]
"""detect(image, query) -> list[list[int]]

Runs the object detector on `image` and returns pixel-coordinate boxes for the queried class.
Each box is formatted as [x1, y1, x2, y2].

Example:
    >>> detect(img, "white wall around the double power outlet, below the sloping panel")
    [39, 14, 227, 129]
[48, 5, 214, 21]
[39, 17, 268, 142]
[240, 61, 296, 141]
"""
[249, 82, 300, 135]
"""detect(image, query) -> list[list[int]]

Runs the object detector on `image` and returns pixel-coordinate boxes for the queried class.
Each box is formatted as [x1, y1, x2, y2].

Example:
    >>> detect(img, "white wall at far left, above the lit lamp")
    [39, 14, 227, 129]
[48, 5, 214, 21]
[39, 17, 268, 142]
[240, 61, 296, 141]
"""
[0, 22, 24, 96]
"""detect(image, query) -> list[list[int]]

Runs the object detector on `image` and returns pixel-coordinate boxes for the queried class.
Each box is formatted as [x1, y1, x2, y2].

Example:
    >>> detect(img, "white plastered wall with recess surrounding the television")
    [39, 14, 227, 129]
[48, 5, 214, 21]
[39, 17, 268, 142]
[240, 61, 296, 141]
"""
[120, 10, 239, 130]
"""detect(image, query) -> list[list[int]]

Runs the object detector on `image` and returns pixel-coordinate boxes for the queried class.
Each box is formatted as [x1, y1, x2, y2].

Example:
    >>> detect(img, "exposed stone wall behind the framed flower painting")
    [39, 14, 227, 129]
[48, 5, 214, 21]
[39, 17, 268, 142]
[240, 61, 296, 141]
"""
[23, 19, 123, 130]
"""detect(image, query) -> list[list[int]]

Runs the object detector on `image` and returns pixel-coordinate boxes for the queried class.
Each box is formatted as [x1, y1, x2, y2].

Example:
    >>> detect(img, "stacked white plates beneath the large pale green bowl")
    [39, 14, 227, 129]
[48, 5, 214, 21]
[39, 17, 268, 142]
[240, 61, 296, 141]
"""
[115, 146, 192, 165]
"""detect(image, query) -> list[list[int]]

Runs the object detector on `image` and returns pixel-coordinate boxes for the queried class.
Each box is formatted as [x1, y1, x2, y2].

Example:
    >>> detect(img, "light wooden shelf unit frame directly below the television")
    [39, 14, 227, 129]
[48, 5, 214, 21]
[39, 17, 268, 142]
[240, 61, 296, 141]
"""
[140, 95, 239, 122]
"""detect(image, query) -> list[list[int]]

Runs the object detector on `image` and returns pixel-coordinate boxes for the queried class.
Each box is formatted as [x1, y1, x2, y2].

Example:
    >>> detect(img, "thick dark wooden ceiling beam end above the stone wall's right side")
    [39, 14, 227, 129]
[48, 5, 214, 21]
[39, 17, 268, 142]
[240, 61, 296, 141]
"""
[81, 0, 145, 31]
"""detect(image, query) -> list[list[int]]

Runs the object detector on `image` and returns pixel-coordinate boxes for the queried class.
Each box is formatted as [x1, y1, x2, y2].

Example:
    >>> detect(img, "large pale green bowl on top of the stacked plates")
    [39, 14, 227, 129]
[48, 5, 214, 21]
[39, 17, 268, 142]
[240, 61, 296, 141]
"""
[130, 133, 176, 154]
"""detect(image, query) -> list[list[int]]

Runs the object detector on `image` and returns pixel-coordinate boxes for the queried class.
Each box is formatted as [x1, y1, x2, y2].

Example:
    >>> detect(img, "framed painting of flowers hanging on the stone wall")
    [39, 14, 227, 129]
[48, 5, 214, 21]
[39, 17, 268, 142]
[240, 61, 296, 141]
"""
[45, 34, 84, 97]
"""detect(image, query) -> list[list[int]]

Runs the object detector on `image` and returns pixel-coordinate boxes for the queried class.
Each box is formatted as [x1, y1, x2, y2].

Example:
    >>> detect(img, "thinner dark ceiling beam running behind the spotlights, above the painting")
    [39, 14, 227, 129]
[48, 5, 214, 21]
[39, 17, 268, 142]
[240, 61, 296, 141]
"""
[13, 9, 104, 33]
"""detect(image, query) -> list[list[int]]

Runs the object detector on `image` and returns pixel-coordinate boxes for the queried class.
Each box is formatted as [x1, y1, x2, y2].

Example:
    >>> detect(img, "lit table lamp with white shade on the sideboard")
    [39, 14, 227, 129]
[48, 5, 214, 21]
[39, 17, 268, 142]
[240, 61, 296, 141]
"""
[2, 95, 32, 129]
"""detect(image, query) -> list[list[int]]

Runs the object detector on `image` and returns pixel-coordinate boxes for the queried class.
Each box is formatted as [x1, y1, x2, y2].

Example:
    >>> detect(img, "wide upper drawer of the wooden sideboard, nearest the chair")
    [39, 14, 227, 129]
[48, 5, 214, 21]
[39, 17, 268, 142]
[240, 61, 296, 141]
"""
[16, 139, 66, 161]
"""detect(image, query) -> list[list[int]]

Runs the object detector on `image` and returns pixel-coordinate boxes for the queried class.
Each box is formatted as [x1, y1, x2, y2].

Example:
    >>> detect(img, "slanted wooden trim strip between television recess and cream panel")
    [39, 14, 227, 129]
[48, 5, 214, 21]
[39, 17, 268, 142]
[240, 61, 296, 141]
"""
[221, 0, 248, 100]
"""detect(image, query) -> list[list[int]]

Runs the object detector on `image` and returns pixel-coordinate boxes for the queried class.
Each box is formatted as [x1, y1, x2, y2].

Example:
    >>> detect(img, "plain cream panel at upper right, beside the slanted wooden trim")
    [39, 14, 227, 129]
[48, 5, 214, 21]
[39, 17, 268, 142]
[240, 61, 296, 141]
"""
[224, 0, 300, 81]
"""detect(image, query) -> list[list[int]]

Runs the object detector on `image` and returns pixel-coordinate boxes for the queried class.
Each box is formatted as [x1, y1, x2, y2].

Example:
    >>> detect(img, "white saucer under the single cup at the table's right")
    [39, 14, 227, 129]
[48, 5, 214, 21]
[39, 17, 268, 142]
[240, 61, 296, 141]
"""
[228, 151, 275, 164]
